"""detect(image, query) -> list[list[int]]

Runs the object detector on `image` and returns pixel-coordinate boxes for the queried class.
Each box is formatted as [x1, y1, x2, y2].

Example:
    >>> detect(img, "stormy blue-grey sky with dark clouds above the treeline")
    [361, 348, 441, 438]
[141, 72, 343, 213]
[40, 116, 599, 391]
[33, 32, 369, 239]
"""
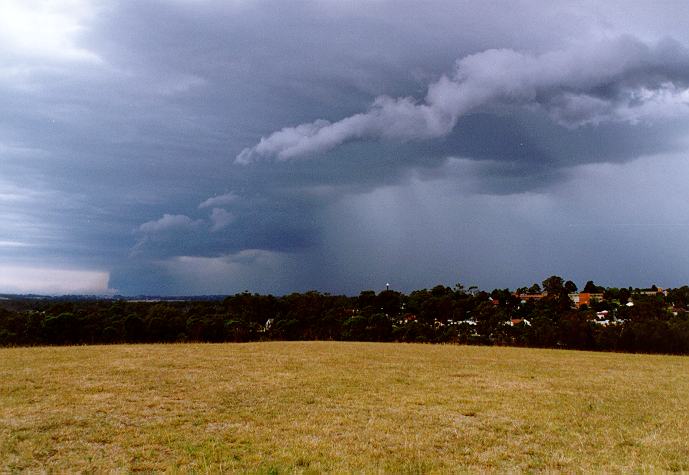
[0, 0, 689, 295]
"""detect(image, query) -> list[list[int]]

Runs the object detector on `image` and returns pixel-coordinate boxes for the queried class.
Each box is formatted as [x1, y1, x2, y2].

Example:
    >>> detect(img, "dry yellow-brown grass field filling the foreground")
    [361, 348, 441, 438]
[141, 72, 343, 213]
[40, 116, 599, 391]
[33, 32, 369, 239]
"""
[0, 342, 689, 473]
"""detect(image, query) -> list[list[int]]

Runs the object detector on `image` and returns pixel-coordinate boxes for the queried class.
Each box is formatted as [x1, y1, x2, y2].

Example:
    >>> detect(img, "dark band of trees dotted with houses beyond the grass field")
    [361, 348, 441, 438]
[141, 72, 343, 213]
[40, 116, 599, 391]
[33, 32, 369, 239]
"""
[0, 276, 689, 354]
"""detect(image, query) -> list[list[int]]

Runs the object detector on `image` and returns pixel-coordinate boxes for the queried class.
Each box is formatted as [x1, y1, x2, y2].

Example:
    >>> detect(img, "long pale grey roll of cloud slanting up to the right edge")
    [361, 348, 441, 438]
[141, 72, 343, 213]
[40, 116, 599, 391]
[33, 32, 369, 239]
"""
[236, 36, 689, 164]
